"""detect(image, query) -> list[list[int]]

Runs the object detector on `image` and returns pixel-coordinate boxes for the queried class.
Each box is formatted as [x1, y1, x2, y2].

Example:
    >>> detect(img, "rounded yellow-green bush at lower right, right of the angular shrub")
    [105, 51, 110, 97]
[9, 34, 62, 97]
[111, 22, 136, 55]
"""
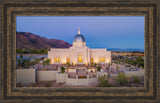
[116, 73, 128, 85]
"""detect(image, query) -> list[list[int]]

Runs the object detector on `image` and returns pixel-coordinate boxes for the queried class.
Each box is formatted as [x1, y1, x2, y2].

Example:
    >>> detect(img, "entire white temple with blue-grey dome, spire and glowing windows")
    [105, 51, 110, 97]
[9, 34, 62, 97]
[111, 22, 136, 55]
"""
[48, 28, 111, 65]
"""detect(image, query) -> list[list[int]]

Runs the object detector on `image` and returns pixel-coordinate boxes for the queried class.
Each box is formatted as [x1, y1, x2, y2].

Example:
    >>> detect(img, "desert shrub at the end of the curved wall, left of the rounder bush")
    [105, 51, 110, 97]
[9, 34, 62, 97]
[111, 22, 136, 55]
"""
[98, 75, 113, 87]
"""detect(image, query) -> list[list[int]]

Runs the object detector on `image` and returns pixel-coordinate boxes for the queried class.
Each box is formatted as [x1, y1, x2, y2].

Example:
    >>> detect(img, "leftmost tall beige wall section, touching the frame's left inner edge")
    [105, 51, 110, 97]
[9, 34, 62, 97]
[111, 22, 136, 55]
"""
[16, 69, 35, 83]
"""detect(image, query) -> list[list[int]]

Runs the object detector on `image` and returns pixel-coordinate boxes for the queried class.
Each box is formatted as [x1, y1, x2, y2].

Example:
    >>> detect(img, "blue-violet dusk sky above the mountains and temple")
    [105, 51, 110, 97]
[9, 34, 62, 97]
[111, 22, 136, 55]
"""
[16, 16, 144, 49]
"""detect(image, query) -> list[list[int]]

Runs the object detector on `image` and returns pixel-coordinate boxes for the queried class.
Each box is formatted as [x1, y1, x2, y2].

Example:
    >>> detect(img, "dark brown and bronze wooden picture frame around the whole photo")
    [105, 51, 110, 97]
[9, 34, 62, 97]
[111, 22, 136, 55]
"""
[0, 0, 160, 103]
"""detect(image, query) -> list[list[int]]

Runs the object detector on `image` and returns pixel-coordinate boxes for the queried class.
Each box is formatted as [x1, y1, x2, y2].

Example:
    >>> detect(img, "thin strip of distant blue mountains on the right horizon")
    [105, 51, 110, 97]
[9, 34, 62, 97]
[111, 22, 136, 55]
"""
[107, 48, 144, 52]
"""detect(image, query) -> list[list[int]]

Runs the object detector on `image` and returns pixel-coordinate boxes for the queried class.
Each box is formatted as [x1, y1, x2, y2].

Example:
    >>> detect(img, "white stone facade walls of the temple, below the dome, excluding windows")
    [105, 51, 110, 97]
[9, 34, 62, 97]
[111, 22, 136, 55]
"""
[48, 43, 111, 64]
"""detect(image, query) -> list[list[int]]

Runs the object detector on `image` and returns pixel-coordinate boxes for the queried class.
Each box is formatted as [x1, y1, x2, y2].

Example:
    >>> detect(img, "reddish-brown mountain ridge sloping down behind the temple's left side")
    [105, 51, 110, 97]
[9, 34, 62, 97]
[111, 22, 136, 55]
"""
[16, 32, 72, 49]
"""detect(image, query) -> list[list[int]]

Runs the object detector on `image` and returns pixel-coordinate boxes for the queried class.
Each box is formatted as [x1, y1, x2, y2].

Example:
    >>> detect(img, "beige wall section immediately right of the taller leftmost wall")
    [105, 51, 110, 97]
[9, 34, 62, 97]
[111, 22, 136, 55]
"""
[37, 70, 58, 82]
